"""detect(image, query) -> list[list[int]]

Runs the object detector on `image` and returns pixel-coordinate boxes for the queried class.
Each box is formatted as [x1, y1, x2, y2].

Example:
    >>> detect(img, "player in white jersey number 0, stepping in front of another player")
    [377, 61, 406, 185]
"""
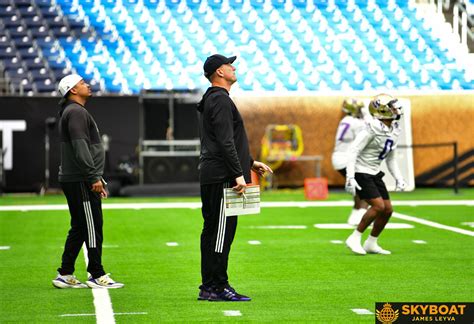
[346, 94, 406, 255]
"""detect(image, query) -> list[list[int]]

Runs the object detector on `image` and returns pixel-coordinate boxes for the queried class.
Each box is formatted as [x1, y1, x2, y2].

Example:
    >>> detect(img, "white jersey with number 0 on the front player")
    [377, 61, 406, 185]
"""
[347, 118, 400, 178]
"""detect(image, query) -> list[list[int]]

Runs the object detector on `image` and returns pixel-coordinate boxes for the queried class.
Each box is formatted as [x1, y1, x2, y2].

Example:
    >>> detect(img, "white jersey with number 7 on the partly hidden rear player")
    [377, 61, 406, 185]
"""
[332, 115, 366, 170]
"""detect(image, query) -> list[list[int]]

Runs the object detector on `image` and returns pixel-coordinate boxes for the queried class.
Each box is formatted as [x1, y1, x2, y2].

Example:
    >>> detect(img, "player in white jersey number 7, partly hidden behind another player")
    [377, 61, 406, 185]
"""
[332, 98, 370, 226]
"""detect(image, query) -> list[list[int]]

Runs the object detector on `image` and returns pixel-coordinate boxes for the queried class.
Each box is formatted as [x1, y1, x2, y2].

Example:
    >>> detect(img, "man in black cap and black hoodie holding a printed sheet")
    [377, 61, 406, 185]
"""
[198, 54, 272, 301]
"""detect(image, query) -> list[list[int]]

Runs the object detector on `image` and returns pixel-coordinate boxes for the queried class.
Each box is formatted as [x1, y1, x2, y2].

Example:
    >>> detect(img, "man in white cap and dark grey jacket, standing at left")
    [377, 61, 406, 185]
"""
[53, 74, 123, 288]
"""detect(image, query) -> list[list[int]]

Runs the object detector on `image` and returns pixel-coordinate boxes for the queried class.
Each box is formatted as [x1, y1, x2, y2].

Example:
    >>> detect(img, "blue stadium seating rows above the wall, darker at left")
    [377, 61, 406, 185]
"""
[0, 0, 474, 95]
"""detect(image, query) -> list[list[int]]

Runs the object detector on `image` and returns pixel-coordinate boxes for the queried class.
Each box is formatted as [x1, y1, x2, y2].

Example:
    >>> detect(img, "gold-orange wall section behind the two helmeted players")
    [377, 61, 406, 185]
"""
[234, 92, 474, 186]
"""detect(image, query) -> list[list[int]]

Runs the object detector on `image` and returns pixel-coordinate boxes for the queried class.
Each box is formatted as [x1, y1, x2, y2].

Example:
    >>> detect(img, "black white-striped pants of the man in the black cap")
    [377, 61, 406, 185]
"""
[201, 183, 237, 289]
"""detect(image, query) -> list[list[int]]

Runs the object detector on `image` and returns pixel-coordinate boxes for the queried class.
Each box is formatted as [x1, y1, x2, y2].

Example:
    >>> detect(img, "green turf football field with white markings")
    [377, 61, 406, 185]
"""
[0, 189, 474, 323]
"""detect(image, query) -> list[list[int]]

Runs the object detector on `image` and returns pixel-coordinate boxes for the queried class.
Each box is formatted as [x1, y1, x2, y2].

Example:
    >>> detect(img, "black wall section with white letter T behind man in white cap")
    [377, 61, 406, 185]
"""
[0, 96, 138, 192]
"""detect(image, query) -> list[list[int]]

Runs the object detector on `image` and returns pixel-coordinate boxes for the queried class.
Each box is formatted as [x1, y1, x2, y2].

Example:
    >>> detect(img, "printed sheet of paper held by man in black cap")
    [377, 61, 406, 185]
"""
[224, 186, 260, 216]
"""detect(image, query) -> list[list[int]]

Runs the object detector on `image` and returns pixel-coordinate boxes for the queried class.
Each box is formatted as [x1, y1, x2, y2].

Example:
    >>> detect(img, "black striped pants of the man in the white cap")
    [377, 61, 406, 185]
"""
[58, 182, 105, 278]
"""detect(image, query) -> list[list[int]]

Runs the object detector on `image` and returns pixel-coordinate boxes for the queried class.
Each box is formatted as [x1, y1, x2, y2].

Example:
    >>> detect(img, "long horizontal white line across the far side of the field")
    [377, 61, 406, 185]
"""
[0, 200, 474, 212]
